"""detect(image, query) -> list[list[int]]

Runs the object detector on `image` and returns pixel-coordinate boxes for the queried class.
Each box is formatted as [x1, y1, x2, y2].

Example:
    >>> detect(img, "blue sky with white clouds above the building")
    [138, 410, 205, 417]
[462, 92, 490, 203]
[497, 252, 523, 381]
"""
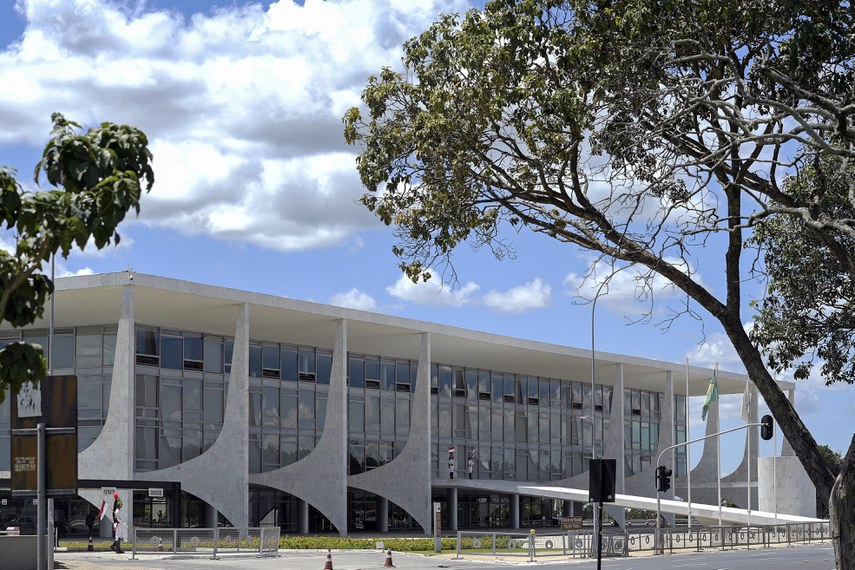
[0, 0, 855, 471]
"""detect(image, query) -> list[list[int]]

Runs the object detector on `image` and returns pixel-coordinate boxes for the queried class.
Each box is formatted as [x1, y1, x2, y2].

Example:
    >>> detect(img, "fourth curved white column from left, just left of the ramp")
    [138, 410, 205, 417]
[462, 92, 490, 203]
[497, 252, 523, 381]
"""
[348, 333, 432, 535]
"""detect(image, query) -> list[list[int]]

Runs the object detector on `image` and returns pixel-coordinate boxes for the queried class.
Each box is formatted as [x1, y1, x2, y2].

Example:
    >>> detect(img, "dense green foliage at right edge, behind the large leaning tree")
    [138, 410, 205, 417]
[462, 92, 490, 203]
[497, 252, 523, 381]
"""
[751, 153, 855, 382]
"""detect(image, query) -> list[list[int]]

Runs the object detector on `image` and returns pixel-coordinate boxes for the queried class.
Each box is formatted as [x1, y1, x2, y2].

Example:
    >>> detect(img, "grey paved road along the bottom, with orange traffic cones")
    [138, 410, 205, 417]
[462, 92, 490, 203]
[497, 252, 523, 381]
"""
[56, 544, 834, 570]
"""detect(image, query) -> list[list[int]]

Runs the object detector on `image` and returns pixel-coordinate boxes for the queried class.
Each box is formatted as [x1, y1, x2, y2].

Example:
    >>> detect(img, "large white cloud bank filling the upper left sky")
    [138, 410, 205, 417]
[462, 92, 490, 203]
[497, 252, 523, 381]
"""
[0, 0, 467, 250]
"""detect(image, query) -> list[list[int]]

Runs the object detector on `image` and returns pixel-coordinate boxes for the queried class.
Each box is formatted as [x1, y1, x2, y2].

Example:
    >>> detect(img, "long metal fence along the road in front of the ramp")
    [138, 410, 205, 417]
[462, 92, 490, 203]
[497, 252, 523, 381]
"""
[457, 522, 831, 560]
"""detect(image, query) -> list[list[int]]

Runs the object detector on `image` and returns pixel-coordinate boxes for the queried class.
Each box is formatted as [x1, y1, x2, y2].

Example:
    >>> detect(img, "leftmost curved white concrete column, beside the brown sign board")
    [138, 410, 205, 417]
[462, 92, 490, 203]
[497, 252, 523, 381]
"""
[77, 285, 136, 478]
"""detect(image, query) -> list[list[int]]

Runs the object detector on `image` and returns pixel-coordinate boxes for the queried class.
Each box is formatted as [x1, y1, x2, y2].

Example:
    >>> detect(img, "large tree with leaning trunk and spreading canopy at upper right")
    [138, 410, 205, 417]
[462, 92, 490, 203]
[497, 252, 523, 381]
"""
[343, 0, 855, 567]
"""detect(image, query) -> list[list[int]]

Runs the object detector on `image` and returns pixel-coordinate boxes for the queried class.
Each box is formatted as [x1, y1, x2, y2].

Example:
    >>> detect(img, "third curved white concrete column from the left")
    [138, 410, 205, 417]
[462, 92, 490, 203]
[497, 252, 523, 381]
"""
[249, 319, 347, 536]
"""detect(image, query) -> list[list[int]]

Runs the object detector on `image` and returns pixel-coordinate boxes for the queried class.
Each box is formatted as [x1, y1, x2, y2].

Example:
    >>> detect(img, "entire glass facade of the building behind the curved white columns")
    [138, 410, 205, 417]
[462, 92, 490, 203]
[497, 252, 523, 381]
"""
[0, 316, 686, 531]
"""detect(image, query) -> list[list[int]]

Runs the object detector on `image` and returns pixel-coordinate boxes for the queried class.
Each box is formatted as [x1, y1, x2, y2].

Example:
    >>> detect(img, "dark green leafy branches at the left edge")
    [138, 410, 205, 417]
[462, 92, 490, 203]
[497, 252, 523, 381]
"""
[0, 113, 154, 402]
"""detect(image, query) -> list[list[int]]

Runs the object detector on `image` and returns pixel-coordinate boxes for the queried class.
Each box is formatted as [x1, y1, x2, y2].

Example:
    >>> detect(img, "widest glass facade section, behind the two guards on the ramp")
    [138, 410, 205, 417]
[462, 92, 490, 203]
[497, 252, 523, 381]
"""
[431, 364, 613, 481]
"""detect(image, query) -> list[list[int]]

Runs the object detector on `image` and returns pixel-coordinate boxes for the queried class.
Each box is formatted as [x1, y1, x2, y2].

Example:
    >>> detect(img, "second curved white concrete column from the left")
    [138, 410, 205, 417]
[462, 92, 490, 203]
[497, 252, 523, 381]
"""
[137, 303, 249, 528]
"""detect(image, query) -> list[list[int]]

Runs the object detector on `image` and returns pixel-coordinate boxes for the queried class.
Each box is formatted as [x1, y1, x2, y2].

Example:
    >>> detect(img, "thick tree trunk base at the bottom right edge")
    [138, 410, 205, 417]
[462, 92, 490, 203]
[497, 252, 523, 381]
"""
[828, 436, 855, 570]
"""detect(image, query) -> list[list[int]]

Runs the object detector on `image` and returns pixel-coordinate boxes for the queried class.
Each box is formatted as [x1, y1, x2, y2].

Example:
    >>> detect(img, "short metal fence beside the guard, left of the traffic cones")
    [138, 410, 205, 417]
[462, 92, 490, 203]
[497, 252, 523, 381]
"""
[132, 526, 279, 558]
